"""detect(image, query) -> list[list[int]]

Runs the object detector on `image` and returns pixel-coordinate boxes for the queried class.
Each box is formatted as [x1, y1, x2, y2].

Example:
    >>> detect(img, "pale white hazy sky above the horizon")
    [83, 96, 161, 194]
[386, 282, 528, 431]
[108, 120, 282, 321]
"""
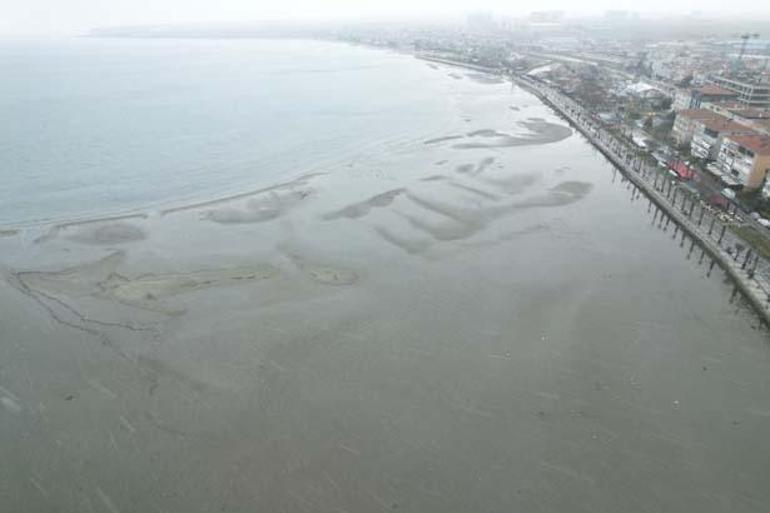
[0, 0, 770, 34]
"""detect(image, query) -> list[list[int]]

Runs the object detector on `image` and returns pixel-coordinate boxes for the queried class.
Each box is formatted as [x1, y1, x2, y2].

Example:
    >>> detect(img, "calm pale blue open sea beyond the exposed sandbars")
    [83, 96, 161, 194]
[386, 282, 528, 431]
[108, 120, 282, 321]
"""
[0, 39, 450, 225]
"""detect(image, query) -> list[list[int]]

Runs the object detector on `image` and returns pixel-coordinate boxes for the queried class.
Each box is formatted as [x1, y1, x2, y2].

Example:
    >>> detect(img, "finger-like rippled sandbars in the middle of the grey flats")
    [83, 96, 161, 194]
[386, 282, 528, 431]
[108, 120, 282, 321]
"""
[322, 154, 592, 255]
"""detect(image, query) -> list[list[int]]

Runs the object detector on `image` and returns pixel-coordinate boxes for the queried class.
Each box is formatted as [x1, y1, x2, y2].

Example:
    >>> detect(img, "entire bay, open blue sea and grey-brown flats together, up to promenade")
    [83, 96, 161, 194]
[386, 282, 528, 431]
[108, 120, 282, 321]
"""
[0, 40, 770, 513]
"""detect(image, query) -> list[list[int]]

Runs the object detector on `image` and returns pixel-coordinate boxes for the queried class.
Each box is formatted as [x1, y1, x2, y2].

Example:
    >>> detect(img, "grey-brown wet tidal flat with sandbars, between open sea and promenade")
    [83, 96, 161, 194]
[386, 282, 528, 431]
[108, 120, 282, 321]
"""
[0, 66, 770, 513]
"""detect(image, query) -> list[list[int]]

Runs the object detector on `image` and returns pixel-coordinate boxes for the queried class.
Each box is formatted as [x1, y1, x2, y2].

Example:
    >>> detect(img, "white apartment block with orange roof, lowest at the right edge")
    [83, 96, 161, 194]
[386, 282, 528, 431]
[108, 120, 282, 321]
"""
[717, 134, 770, 190]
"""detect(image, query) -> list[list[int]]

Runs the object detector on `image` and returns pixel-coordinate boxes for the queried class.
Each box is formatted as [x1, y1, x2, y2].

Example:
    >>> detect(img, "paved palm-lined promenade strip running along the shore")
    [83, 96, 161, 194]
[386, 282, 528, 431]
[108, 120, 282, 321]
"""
[514, 77, 770, 325]
